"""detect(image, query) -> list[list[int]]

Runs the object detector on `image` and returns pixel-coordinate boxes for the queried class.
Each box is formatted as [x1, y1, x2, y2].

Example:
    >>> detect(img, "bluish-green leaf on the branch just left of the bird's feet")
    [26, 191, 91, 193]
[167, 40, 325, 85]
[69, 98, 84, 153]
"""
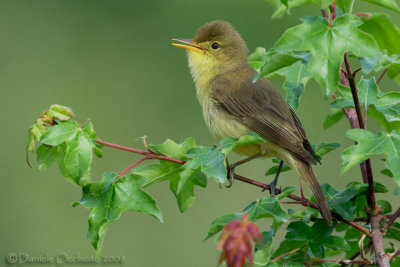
[184, 146, 227, 183]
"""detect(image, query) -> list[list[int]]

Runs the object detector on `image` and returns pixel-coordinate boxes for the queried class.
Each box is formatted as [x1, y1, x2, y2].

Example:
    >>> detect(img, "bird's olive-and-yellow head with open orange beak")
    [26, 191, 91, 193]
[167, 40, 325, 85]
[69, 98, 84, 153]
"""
[173, 21, 247, 80]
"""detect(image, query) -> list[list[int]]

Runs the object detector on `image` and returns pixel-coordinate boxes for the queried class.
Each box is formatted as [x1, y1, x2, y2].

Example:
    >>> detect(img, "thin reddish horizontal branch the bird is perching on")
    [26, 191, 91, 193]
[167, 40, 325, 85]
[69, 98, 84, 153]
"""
[95, 139, 369, 235]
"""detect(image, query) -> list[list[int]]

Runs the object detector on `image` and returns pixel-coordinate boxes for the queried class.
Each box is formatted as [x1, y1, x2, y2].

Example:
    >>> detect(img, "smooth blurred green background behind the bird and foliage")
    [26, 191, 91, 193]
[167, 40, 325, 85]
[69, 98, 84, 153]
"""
[0, 0, 399, 266]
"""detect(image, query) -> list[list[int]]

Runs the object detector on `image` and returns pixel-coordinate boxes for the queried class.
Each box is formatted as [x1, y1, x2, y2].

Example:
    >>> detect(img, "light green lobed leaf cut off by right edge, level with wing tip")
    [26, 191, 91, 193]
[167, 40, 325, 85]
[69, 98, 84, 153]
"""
[341, 129, 400, 186]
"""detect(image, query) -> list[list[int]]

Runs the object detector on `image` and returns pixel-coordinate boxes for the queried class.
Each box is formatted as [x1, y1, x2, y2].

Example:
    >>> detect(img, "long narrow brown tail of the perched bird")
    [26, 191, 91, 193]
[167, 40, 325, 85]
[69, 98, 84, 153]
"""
[289, 157, 332, 225]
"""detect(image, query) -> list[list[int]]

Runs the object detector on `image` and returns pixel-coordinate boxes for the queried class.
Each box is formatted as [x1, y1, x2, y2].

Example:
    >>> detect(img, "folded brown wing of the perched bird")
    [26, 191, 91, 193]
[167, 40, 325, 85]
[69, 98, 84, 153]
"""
[212, 66, 317, 164]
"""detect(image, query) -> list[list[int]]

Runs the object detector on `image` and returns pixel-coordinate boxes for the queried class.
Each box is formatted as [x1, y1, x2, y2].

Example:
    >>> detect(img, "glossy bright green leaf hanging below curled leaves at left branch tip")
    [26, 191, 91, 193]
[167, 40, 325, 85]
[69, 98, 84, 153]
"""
[64, 131, 94, 184]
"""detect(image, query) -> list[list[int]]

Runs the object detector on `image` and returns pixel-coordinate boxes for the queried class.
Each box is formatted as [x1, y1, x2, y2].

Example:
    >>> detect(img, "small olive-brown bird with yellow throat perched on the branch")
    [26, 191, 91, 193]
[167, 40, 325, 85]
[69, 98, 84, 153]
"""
[173, 21, 332, 224]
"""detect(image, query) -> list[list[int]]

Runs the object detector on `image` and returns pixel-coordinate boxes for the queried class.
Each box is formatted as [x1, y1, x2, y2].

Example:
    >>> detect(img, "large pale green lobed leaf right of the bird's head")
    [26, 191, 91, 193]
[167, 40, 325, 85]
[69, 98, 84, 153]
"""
[276, 14, 381, 96]
